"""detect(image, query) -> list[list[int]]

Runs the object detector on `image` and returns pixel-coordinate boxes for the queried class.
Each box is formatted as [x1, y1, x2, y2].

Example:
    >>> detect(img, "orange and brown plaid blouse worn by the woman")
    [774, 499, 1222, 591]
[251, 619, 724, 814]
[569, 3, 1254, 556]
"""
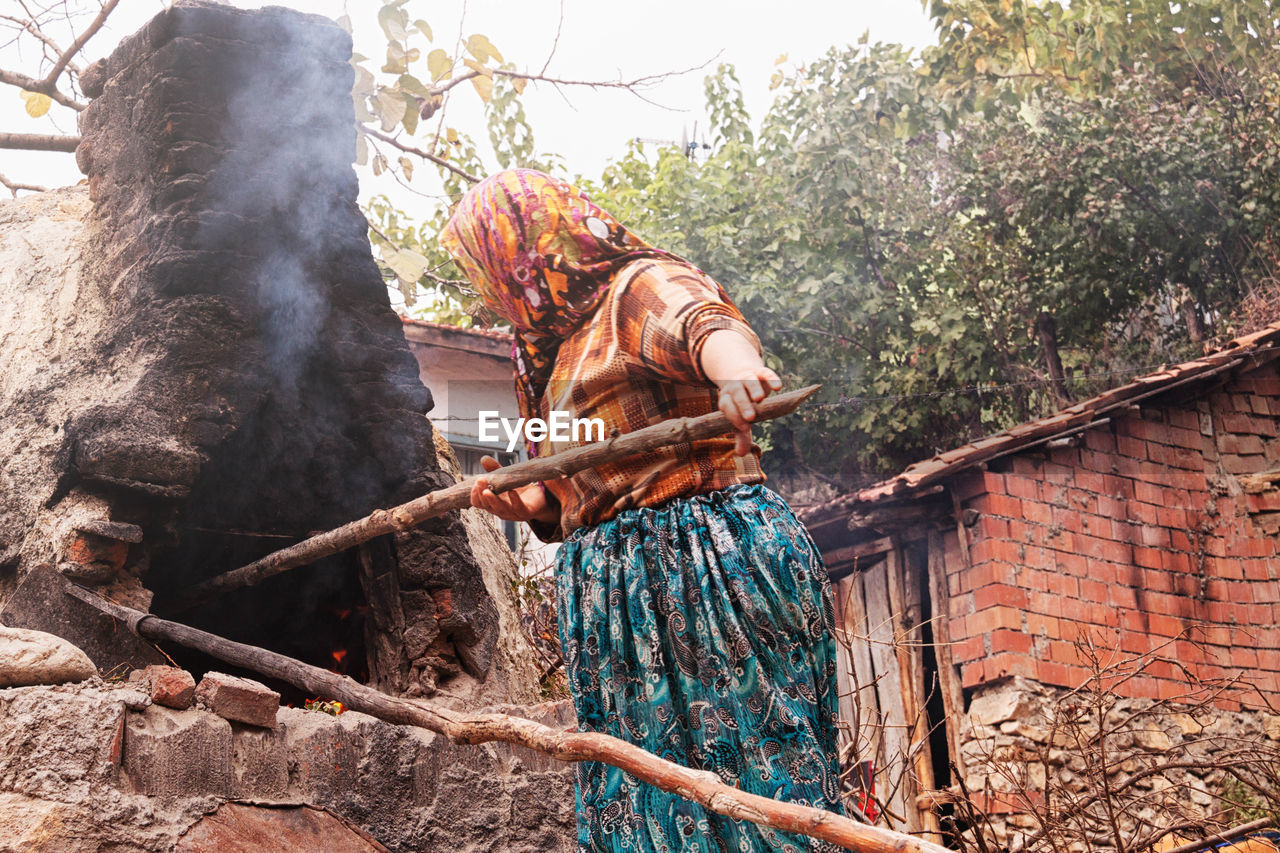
[532, 259, 764, 542]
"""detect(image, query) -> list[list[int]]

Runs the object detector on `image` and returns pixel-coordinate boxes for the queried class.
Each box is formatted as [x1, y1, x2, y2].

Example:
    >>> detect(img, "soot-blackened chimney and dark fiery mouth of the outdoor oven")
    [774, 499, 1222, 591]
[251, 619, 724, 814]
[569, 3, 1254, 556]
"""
[0, 1, 497, 701]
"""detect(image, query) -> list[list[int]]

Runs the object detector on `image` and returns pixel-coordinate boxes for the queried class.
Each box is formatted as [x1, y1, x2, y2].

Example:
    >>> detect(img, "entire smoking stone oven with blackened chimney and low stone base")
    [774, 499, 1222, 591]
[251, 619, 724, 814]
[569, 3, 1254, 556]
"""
[0, 1, 572, 850]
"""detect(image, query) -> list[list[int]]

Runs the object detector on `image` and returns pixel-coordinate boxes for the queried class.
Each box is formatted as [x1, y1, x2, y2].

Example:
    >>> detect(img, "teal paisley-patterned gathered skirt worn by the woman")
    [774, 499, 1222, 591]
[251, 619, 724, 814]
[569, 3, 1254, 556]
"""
[557, 485, 844, 853]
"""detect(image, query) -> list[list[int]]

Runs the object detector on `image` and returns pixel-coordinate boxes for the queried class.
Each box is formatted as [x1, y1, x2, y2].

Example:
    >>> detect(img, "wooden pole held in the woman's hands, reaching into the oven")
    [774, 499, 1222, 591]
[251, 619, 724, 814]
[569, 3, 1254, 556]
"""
[168, 386, 818, 613]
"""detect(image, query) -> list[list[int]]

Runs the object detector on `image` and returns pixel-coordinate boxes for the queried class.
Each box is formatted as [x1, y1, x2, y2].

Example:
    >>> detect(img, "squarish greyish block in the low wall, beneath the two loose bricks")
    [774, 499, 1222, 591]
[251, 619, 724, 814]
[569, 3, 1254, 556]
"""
[124, 706, 232, 797]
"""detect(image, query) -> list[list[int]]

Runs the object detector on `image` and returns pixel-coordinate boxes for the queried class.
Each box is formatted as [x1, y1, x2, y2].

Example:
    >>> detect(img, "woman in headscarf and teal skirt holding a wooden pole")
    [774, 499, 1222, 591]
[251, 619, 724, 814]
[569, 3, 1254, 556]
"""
[442, 169, 841, 853]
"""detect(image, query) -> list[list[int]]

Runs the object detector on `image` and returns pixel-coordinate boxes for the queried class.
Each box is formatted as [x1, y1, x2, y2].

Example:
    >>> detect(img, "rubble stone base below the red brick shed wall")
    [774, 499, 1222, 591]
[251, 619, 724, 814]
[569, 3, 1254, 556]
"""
[959, 674, 1280, 853]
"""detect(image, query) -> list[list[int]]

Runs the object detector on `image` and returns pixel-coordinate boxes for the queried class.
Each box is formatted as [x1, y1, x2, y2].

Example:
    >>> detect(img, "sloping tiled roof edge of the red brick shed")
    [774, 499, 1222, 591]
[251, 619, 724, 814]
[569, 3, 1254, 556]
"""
[801, 324, 1280, 521]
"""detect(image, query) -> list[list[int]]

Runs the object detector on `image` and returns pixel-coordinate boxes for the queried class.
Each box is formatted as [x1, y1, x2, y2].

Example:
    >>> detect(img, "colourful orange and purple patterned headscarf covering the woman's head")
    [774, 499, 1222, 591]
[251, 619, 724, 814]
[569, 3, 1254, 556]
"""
[440, 169, 680, 427]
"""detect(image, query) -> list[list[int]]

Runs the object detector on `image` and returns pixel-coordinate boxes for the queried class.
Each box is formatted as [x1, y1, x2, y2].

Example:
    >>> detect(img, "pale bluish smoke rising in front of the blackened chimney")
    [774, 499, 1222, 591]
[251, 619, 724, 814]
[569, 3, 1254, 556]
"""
[192, 3, 355, 401]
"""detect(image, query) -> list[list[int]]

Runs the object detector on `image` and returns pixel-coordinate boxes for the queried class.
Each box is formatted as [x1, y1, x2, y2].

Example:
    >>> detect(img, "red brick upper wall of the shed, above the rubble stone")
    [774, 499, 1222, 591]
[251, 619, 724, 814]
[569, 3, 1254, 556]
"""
[947, 362, 1280, 707]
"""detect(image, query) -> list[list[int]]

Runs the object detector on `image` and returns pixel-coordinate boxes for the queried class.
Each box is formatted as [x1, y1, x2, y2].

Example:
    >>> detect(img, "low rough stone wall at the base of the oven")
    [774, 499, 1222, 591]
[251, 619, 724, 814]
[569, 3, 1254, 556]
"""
[0, 679, 575, 853]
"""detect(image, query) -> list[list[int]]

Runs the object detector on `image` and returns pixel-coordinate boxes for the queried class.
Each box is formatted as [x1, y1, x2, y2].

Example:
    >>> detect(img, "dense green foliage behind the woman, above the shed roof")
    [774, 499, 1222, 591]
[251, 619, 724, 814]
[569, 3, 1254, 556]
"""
[591, 0, 1280, 483]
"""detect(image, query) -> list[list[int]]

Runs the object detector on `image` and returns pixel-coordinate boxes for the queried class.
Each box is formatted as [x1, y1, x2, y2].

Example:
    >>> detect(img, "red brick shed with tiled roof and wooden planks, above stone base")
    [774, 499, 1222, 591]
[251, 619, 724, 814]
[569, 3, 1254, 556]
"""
[801, 325, 1280, 831]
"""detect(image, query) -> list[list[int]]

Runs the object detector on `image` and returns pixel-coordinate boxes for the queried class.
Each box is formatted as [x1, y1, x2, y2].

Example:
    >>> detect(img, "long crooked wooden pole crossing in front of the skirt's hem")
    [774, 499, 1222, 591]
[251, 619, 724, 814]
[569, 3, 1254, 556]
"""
[68, 584, 950, 853]
